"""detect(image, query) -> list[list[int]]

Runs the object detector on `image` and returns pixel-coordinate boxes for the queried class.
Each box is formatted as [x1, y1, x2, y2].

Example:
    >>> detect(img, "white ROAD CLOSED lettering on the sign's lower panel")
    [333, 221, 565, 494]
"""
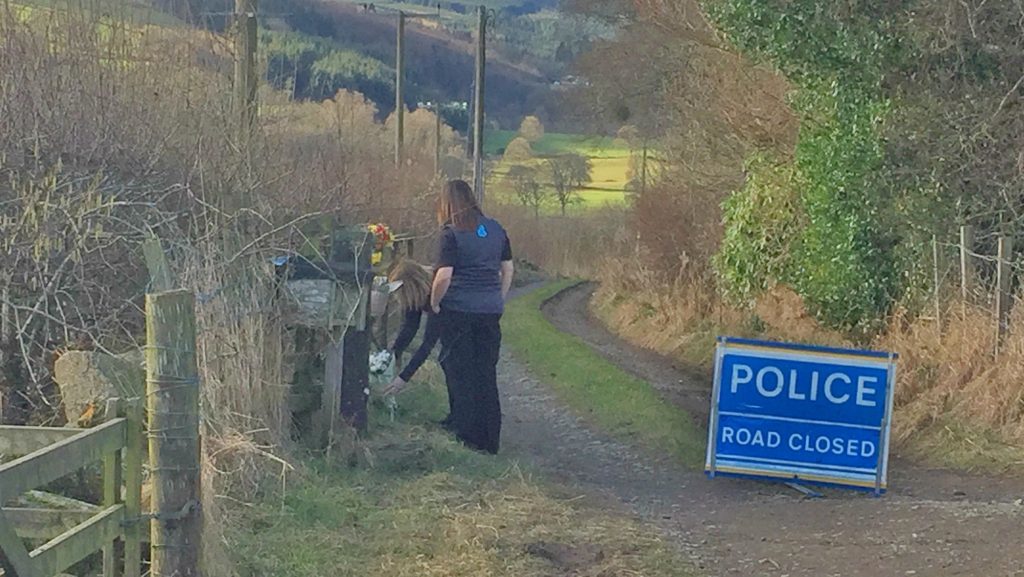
[720, 425, 878, 458]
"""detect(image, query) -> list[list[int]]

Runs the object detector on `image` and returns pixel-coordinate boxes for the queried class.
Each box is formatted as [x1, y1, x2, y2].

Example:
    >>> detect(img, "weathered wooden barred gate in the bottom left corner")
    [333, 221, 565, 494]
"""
[0, 400, 146, 577]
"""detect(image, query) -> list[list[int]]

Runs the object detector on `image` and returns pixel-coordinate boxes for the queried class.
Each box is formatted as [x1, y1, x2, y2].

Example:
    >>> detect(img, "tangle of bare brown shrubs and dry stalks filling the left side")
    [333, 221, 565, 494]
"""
[0, 0, 444, 575]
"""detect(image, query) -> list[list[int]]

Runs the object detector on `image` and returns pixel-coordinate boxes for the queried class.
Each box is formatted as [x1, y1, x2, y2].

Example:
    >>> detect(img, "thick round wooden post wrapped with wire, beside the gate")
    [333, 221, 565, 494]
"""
[145, 290, 202, 577]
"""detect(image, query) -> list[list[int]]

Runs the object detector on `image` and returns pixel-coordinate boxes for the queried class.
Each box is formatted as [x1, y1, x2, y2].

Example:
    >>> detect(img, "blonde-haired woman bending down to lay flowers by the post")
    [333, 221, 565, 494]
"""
[385, 258, 454, 425]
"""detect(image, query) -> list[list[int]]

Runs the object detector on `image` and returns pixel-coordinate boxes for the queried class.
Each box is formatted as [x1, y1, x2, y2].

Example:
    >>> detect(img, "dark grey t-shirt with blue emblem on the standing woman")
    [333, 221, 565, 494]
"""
[437, 216, 512, 315]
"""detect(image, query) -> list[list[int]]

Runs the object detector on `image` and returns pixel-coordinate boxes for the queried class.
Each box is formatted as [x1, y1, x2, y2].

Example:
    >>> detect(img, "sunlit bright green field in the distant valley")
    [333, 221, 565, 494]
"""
[484, 130, 630, 212]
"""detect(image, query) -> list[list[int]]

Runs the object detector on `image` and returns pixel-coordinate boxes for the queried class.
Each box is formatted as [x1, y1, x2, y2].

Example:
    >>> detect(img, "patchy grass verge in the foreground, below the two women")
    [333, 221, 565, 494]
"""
[226, 367, 704, 577]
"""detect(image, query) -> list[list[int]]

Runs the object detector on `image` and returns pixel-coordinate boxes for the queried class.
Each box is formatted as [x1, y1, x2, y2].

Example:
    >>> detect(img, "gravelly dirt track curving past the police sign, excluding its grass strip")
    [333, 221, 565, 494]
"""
[501, 285, 1024, 577]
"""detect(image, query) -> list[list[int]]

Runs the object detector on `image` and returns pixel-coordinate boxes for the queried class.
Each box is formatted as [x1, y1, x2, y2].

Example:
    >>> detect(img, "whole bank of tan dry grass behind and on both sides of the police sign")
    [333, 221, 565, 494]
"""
[594, 262, 1024, 470]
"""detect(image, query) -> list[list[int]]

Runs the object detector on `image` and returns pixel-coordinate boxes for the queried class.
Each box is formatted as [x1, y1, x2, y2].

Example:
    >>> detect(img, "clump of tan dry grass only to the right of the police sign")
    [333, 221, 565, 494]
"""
[876, 305, 1024, 468]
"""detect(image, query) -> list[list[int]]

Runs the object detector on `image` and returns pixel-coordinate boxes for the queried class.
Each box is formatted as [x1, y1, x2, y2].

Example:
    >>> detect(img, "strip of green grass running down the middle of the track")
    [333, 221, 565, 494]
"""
[502, 281, 705, 467]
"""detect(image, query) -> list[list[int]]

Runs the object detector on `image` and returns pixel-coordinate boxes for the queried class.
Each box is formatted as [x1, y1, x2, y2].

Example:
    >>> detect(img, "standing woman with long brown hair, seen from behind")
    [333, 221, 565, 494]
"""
[430, 180, 514, 454]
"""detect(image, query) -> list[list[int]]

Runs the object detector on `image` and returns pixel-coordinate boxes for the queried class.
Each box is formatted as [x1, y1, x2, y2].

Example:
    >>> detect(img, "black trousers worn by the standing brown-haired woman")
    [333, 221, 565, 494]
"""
[441, 311, 502, 454]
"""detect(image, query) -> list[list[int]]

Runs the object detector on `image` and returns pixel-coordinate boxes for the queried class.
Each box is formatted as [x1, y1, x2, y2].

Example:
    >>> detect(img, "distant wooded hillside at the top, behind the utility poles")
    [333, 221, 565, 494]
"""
[134, 0, 609, 130]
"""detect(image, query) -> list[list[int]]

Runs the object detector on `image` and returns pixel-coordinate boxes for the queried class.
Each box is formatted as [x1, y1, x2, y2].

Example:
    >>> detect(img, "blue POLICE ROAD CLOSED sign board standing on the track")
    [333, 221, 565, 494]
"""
[705, 337, 896, 493]
